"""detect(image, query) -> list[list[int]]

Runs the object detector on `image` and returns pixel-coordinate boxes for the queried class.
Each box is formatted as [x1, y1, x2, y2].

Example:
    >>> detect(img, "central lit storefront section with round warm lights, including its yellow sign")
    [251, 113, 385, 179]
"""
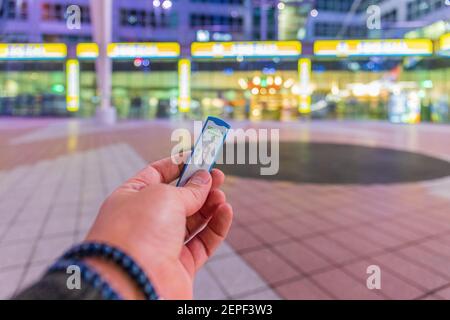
[191, 41, 308, 120]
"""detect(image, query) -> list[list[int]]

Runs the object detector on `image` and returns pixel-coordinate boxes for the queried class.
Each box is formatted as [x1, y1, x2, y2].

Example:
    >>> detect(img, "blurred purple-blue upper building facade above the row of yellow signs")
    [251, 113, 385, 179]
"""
[0, 0, 450, 44]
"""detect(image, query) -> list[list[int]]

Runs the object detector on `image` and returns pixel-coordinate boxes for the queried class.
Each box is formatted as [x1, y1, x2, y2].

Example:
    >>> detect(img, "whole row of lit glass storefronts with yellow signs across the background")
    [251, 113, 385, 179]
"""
[0, 34, 450, 123]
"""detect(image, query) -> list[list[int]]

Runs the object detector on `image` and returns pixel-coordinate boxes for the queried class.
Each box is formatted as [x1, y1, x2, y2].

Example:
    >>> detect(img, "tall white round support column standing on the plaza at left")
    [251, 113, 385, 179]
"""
[90, 0, 117, 124]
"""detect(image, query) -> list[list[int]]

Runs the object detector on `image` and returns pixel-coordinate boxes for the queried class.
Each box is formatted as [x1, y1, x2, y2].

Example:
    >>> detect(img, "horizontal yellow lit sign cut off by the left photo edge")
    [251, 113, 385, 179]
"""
[0, 43, 67, 60]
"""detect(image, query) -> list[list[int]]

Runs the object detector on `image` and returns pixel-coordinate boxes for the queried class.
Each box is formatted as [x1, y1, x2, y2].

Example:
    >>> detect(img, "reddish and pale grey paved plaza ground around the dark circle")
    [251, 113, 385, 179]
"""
[0, 119, 450, 299]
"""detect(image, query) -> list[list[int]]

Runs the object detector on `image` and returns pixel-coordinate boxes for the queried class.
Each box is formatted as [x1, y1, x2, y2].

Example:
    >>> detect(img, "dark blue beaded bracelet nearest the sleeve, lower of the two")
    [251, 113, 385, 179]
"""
[47, 259, 122, 300]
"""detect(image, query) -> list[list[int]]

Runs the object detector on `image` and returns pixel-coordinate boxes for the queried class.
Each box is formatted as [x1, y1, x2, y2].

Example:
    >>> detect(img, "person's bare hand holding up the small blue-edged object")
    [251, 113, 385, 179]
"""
[86, 155, 233, 299]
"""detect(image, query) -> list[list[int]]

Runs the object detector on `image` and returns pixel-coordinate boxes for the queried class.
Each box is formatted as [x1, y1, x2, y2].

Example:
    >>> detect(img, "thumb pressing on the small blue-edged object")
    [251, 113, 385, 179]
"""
[177, 170, 212, 216]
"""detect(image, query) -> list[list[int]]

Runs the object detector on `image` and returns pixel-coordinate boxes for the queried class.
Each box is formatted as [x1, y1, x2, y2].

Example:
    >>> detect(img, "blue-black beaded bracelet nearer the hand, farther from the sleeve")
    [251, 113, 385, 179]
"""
[62, 242, 159, 300]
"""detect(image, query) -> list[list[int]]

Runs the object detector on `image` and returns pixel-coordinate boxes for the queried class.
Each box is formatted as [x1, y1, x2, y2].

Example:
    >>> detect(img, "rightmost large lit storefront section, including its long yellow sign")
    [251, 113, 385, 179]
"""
[312, 39, 450, 123]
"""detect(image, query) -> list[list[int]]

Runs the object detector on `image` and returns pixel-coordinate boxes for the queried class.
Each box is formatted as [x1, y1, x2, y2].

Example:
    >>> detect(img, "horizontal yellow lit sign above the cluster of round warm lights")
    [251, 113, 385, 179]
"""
[191, 41, 302, 58]
